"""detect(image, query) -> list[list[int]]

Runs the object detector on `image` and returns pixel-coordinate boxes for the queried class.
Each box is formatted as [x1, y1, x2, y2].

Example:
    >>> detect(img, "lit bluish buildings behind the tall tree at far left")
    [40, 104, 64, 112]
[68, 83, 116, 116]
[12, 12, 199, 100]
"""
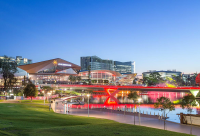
[0, 56, 32, 66]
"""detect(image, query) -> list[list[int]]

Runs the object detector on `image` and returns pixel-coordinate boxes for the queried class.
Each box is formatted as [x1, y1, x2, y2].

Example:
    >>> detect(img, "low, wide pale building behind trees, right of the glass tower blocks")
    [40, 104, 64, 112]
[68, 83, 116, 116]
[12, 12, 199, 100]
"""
[142, 70, 182, 78]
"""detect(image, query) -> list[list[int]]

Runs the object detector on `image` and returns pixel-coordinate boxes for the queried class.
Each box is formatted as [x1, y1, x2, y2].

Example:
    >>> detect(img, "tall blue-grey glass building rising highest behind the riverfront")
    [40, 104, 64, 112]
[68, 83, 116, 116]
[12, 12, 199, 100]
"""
[80, 56, 135, 74]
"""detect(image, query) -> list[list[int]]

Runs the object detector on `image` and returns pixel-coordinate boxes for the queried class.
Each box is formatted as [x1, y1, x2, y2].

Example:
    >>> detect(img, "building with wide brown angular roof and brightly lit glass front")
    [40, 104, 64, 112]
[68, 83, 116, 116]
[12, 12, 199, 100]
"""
[18, 58, 81, 84]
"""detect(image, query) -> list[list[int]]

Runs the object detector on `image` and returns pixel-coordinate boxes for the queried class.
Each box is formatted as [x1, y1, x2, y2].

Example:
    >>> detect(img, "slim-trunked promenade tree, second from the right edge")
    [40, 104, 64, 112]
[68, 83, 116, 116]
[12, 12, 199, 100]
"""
[154, 97, 175, 130]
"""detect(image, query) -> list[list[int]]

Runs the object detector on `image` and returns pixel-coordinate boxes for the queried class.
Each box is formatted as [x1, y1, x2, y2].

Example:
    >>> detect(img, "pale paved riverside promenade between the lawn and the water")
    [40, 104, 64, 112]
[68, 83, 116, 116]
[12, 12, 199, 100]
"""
[54, 104, 200, 136]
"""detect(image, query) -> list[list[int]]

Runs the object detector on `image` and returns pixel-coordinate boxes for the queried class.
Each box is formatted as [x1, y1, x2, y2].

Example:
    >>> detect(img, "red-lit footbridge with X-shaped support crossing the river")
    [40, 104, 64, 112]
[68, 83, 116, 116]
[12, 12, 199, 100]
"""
[51, 85, 200, 105]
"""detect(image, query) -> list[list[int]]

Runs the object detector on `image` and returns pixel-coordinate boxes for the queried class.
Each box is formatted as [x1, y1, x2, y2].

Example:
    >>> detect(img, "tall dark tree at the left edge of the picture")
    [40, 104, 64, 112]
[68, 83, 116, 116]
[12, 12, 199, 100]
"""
[0, 56, 17, 91]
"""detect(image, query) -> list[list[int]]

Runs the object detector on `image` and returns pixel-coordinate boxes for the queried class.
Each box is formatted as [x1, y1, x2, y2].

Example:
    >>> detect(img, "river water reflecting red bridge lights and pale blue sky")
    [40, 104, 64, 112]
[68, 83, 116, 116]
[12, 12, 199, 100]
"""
[79, 90, 200, 123]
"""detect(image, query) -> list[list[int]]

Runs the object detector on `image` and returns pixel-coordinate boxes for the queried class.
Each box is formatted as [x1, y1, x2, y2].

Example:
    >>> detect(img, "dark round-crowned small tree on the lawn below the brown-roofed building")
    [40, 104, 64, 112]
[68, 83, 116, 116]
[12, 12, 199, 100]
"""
[24, 84, 38, 102]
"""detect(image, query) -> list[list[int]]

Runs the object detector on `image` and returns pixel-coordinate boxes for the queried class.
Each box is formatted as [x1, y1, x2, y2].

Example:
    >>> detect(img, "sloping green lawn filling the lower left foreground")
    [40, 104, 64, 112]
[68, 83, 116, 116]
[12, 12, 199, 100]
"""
[0, 103, 191, 136]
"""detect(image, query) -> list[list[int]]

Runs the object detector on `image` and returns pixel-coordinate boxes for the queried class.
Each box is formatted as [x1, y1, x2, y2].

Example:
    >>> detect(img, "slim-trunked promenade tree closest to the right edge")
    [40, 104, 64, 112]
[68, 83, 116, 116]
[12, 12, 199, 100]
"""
[180, 94, 197, 134]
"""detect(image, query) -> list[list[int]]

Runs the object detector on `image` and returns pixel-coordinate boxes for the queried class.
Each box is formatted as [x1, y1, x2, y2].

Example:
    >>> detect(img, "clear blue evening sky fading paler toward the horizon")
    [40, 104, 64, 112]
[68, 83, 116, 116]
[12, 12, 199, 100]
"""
[0, 0, 200, 74]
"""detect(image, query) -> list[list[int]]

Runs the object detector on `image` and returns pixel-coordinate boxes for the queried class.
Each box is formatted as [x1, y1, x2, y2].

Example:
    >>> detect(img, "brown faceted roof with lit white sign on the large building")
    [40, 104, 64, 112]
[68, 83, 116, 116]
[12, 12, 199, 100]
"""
[18, 58, 81, 74]
